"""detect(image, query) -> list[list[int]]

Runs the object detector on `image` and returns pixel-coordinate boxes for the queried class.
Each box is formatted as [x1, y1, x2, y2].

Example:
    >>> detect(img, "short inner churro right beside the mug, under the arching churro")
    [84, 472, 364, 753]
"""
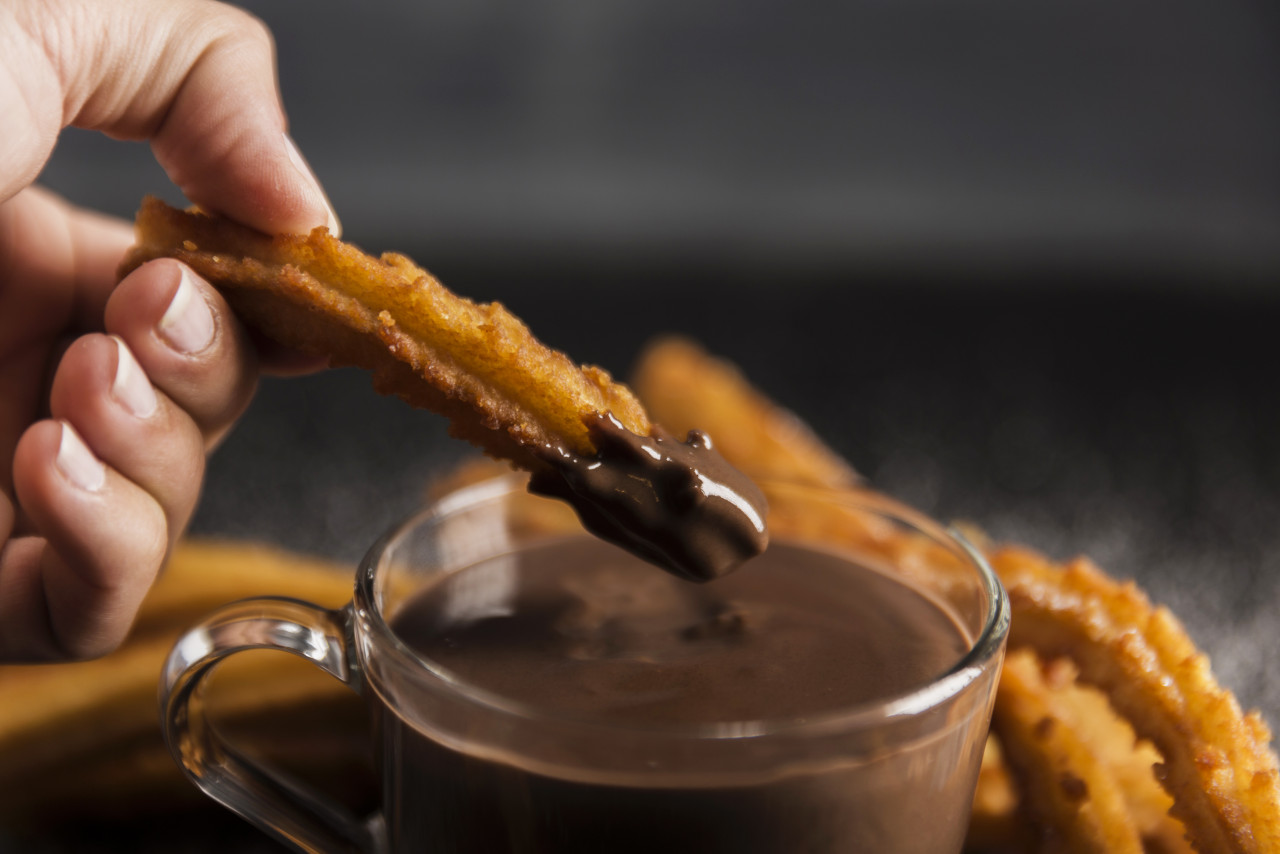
[992, 650, 1143, 854]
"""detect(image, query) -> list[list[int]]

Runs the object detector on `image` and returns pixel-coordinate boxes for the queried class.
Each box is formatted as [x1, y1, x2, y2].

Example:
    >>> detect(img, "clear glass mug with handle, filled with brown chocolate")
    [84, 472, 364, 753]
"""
[160, 478, 1009, 854]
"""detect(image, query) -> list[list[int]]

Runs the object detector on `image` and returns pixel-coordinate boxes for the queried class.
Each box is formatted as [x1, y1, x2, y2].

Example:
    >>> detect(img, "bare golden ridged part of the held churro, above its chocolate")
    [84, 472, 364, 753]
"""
[120, 198, 650, 471]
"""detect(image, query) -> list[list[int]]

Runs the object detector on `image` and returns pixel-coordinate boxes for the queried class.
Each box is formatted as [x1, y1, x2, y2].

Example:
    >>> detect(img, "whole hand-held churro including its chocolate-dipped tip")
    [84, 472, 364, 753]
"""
[120, 198, 768, 581]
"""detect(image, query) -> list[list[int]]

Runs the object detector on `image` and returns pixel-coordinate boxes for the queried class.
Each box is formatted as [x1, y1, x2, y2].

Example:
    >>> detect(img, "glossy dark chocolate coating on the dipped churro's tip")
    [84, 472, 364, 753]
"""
[529, 415, 769, 581]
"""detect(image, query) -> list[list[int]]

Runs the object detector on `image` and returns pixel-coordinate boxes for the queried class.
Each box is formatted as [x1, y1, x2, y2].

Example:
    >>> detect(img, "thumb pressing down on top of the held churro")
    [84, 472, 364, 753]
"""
[0, 0, 338, 232]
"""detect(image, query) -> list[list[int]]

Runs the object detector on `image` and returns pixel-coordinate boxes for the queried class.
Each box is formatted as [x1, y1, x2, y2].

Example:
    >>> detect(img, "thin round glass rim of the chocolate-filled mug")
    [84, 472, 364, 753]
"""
[355, 475, 1010, 739]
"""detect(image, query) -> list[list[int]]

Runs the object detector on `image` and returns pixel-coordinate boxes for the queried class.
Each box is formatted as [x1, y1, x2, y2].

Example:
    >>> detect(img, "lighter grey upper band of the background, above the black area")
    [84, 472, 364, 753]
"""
[45, 0, 1280, 282]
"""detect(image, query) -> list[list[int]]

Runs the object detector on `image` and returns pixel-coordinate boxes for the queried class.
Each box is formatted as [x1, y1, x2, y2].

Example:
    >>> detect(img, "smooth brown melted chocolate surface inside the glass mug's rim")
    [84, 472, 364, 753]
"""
[394, 536, 969, 725]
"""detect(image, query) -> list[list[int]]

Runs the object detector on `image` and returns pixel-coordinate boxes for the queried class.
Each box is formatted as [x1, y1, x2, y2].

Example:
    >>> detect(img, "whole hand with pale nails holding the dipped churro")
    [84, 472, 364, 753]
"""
[0, 0, 338, 661]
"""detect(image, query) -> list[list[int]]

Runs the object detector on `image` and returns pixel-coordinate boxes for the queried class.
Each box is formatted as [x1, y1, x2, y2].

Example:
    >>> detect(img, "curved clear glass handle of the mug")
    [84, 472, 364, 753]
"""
[160, 597, 380, 854]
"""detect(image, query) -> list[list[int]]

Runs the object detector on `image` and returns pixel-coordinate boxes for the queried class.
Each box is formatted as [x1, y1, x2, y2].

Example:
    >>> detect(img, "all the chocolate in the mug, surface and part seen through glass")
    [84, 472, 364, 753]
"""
[375, 538, 984, 854]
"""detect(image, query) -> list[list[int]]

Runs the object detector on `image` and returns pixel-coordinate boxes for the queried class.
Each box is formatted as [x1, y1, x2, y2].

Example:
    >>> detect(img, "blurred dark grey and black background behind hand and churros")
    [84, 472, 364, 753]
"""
[35, 0, 1280, 725]
